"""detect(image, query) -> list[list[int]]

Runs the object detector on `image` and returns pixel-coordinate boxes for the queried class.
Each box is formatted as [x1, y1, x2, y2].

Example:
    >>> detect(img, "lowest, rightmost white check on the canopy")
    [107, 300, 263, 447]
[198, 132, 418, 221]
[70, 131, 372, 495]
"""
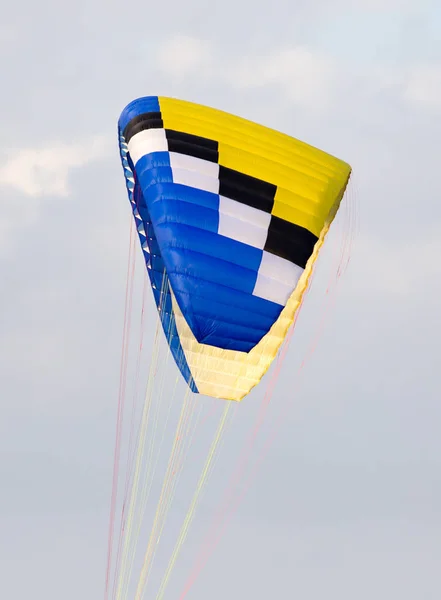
[253, 251, 304, 306]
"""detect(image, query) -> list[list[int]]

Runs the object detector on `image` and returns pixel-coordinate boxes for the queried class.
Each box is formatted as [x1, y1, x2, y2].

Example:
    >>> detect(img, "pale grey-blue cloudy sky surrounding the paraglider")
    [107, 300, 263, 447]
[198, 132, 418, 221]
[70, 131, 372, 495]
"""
[0, 0, 441, 600]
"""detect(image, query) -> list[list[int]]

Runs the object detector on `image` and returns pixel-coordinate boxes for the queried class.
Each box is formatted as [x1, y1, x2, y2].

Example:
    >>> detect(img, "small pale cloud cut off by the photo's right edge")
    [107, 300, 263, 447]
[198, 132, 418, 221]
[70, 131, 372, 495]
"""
[404, 64, 441, 110]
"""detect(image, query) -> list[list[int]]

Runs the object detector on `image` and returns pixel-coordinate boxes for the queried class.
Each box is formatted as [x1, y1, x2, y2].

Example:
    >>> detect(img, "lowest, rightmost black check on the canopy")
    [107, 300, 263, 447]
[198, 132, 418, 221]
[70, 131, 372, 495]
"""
[264, 215, 318, 268]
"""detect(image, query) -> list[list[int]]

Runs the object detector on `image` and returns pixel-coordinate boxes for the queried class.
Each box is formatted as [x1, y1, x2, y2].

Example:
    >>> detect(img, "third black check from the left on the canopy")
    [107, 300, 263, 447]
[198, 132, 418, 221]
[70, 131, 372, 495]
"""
[219, 165, 277, 213]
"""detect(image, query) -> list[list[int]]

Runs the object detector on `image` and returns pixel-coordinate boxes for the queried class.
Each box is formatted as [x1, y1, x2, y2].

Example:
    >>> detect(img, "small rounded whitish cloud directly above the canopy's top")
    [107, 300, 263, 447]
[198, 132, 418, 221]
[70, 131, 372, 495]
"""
[158, 35, 212, 81]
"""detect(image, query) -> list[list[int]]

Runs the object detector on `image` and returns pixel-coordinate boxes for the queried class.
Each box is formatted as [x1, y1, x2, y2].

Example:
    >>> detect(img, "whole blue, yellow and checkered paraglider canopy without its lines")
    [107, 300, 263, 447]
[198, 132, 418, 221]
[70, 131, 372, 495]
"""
[118, 96, 351, 400]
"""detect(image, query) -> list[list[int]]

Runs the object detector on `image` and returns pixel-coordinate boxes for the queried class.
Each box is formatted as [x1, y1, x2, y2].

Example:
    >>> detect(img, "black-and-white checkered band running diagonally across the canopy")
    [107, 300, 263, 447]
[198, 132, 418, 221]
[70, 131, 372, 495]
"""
[128, 124, 315, 306]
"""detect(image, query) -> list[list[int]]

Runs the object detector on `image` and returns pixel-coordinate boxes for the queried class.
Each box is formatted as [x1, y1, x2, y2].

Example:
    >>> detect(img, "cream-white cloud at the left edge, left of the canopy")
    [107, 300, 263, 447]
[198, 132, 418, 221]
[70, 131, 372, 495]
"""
[0, 137, 110, 252]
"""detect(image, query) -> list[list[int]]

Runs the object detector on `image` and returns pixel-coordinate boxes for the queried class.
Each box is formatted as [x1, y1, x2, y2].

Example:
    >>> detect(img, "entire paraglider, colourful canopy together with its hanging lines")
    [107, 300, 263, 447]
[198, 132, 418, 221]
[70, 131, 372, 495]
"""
[105, 96, 356, 600]
